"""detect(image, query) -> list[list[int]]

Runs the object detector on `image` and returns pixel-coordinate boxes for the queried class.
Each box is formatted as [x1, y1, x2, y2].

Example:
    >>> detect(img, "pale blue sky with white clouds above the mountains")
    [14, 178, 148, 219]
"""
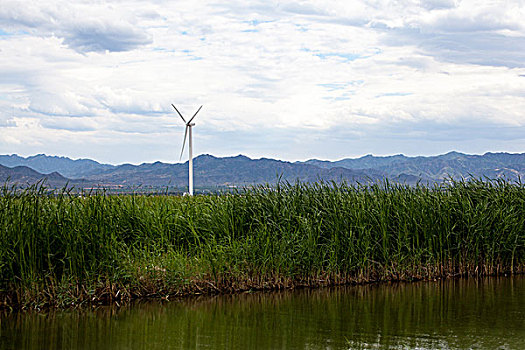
[0, 0, 525, 164]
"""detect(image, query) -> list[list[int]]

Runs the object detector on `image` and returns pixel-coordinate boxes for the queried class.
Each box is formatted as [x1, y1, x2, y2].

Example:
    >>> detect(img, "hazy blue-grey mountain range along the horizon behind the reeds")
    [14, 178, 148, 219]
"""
[0, 152, 525, 188]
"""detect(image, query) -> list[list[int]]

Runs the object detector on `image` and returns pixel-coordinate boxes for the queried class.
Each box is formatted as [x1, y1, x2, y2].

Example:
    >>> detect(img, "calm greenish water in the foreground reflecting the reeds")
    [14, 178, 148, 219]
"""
[0, 277, 525, 349]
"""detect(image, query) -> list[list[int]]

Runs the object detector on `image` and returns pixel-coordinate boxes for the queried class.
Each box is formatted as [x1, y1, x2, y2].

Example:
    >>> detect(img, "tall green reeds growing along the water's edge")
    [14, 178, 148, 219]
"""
[0, 181, 525, 307]
